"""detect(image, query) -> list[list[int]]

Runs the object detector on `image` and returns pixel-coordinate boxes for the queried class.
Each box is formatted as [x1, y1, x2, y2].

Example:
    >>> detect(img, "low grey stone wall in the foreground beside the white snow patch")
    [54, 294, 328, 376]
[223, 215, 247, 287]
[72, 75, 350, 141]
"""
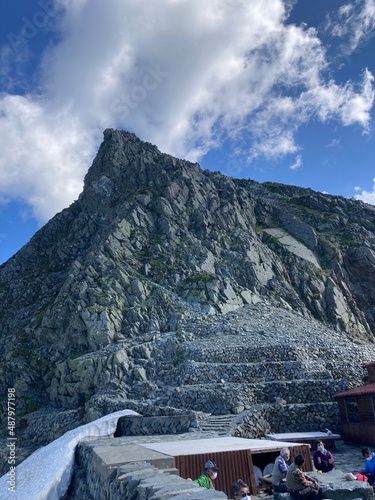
[65, 438, 228, 500]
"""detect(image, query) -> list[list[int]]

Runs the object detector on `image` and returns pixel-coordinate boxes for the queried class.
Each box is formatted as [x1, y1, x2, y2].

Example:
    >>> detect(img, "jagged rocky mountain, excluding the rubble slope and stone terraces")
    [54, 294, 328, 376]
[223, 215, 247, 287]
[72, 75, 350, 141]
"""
[0, 129, 375, 472]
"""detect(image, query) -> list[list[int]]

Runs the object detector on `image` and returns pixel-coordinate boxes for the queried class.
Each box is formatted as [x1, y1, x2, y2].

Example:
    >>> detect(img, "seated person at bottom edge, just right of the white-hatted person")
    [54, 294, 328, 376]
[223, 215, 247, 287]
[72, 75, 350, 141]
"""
[286, 455, 322, 500]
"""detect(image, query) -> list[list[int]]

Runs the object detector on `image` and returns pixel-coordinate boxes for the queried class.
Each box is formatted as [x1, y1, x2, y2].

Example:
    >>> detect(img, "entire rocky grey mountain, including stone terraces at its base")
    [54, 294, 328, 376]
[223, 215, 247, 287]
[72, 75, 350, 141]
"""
[0, 130, 375, 468]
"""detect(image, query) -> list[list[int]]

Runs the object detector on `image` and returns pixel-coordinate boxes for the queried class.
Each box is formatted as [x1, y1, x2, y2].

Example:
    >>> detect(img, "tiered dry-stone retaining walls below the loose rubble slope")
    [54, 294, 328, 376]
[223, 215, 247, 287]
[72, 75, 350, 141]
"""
[139, 335, 362, 438]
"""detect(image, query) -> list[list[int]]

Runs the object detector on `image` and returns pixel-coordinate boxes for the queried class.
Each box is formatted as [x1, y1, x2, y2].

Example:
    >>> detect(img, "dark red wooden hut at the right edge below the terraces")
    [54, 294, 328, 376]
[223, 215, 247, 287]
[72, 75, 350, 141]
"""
[333, 362, 375, 446]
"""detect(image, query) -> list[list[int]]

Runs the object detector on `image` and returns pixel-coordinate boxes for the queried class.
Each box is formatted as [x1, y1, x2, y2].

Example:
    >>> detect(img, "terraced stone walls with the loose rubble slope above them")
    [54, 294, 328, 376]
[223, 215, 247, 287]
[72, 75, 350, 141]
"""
[128, 300, 375, 438]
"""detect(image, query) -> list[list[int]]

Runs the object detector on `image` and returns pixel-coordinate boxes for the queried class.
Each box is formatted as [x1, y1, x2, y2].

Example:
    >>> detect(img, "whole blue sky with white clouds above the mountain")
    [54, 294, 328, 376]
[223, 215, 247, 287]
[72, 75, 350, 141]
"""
[0, 0, 375, 263]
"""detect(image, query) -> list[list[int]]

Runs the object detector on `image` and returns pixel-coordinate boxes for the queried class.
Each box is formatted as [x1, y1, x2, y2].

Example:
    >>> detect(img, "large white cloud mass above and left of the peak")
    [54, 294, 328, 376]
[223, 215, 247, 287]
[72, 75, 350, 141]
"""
[0, 0, 374, 221]
